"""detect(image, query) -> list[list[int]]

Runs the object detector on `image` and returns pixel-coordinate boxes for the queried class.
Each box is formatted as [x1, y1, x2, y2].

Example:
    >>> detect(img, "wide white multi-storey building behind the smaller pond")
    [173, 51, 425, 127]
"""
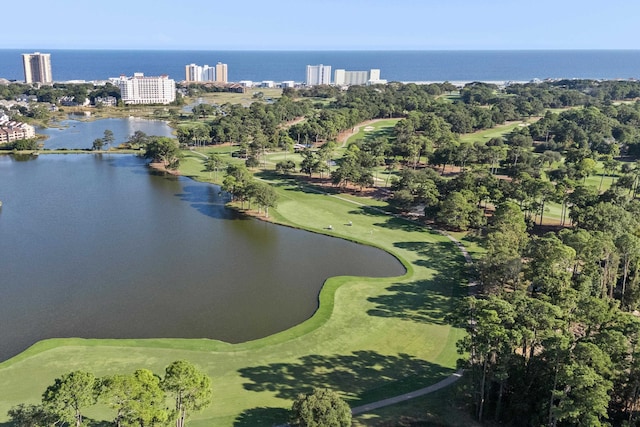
[117, 73, 176, 104]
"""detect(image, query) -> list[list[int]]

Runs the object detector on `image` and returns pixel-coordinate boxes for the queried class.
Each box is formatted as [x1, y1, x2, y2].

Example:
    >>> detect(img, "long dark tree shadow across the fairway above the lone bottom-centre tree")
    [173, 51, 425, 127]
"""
[238, 350, 452, 406]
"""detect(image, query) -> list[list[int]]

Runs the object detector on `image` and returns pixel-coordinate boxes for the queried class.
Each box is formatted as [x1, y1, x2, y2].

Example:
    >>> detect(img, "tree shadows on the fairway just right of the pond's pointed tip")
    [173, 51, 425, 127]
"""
[368, 242, 467, 325]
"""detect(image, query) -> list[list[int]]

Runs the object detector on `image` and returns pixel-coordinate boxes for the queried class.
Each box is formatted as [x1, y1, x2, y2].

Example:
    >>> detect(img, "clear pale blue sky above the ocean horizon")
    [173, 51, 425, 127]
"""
[5, 0, 640, 50]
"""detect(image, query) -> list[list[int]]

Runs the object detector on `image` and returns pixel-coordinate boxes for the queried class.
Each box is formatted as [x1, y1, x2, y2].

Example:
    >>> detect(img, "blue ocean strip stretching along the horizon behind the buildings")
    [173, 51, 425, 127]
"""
[0, 49, 640, 82]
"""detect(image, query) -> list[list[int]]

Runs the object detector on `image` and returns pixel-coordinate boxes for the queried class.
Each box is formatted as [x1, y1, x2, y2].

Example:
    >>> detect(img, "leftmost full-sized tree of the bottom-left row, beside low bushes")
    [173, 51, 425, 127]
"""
[42, 371, 96, 427]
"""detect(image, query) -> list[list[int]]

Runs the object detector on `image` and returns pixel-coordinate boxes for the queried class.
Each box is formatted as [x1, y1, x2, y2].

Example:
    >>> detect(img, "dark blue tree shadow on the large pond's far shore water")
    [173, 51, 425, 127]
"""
[175, 185, 248, 220]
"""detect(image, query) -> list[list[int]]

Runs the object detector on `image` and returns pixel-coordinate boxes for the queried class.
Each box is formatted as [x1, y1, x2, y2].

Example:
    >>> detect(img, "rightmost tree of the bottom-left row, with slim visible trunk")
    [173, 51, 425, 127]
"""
[162, 360, 211, 427]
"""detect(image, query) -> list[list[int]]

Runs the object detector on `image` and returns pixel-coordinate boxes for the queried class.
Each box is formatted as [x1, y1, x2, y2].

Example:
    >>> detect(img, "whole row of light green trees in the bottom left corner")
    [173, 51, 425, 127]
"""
[9, 360, 212, 427]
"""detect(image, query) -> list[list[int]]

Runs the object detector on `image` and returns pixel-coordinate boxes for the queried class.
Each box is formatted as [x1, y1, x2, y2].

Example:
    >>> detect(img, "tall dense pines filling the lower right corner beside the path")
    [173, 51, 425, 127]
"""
[454, 192, 640, 426]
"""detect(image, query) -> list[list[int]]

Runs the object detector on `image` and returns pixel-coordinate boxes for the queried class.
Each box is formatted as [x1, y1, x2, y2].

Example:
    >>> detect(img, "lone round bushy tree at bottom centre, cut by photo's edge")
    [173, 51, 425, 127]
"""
[291, 388, 351, 427]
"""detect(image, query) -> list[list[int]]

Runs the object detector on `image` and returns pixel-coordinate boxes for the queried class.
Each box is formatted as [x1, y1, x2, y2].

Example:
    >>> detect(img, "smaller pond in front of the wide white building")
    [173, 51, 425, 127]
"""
[36, 117, 172, 149]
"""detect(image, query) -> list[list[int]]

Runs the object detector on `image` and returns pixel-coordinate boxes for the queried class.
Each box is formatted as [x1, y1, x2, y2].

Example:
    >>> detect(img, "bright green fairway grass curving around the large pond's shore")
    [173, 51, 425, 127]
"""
[0, 147, 466, 427]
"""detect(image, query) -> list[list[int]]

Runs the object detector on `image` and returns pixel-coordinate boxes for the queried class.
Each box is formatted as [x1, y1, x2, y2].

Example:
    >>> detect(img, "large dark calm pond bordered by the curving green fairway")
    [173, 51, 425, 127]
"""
[0, 154, 404, 360]
